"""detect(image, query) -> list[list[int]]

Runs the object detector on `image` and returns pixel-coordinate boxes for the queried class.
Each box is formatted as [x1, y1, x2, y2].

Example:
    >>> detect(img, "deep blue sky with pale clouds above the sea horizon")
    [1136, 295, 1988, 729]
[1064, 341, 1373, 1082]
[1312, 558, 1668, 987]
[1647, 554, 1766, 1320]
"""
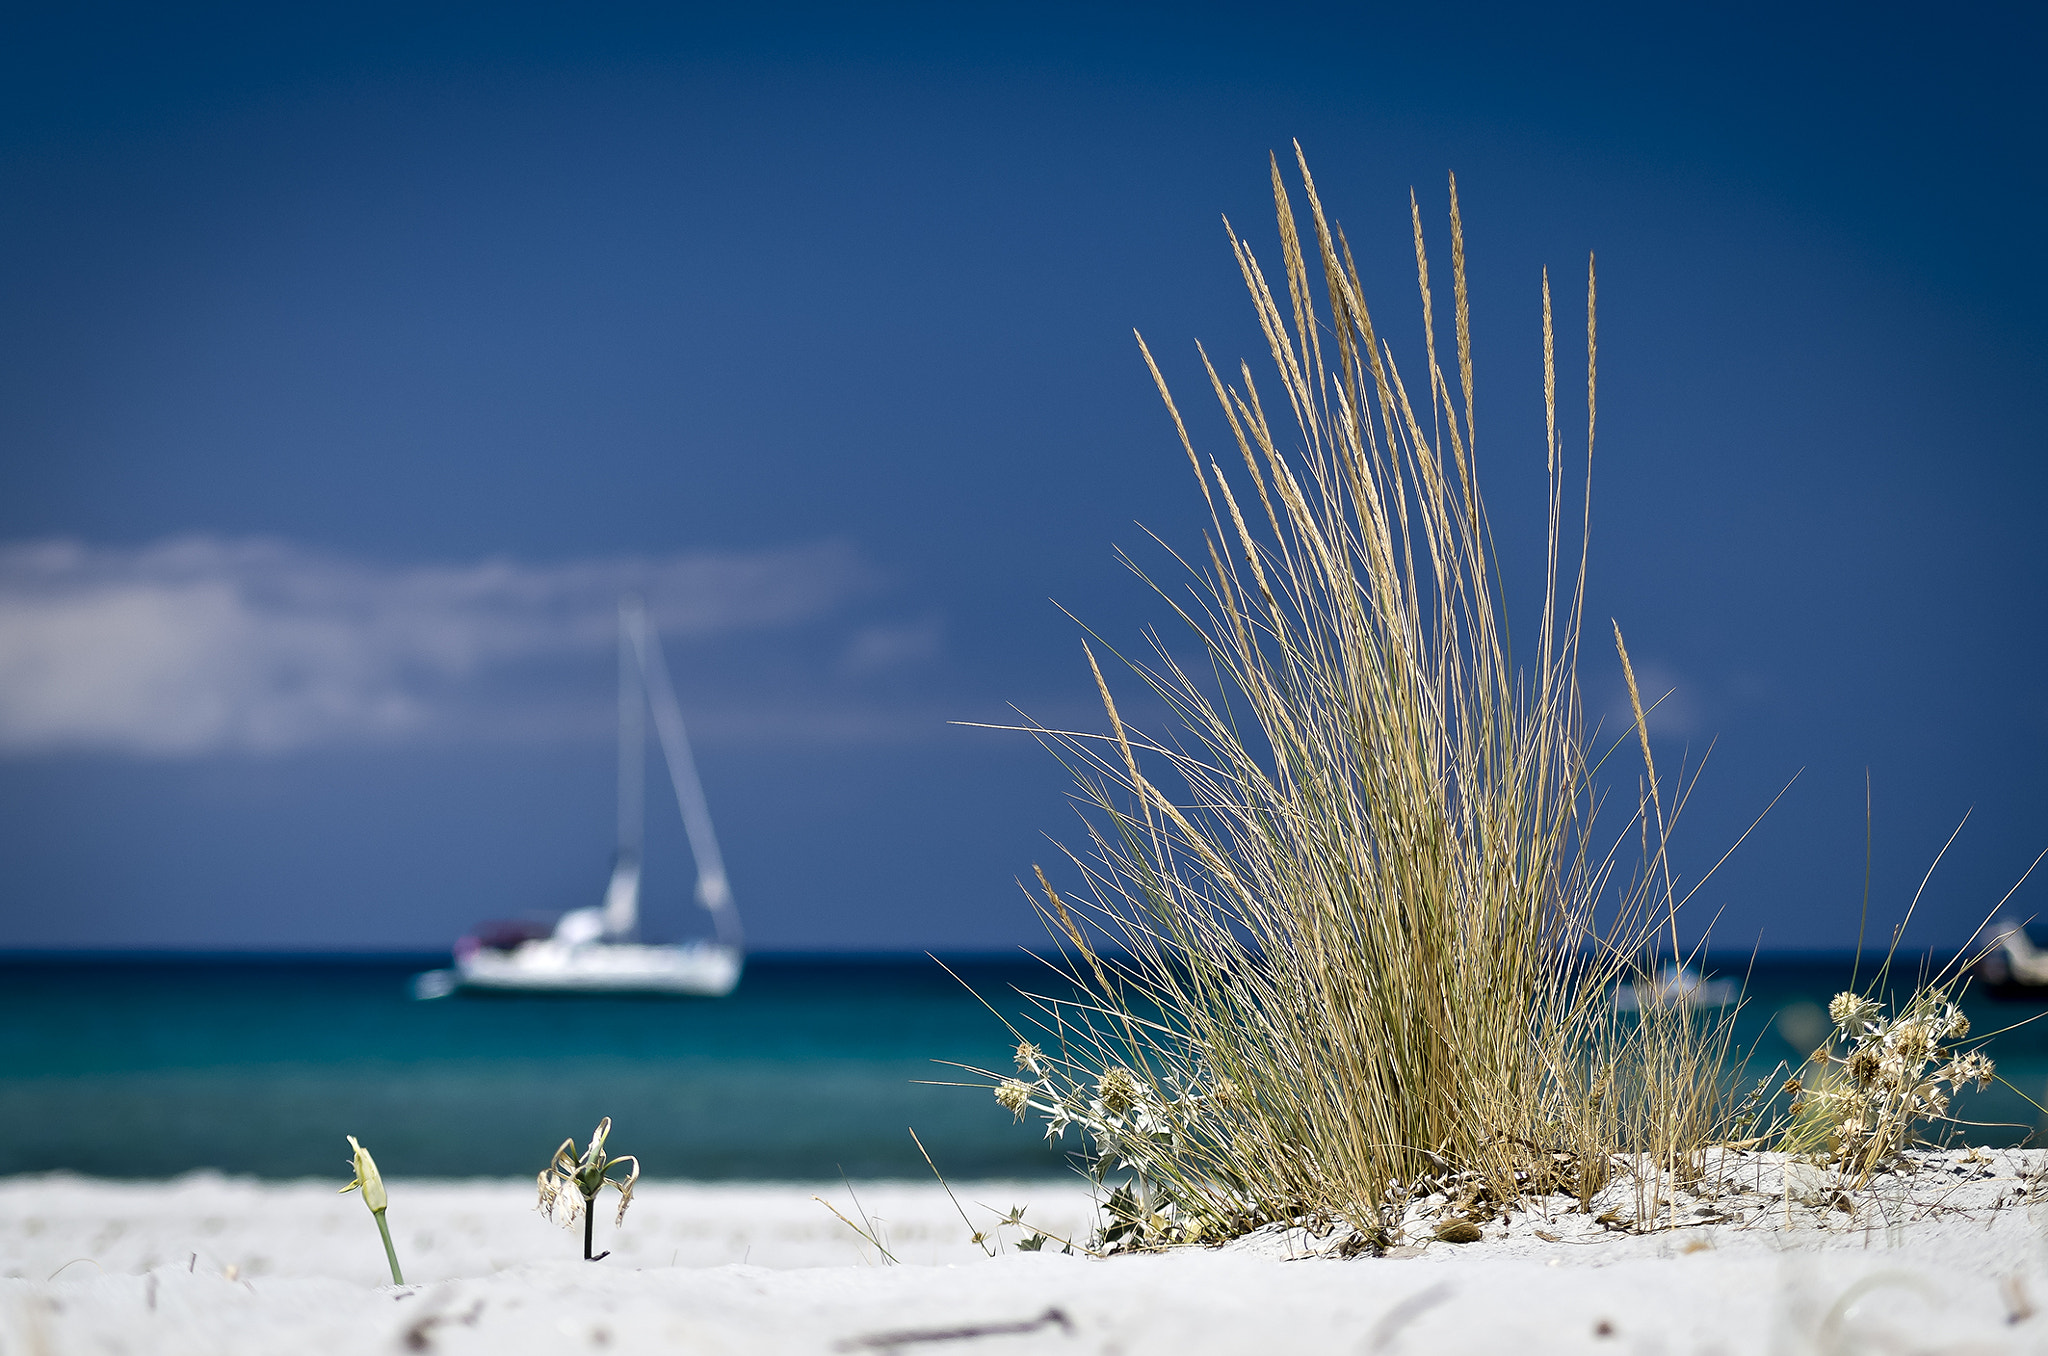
[0, 6, 2048, 948]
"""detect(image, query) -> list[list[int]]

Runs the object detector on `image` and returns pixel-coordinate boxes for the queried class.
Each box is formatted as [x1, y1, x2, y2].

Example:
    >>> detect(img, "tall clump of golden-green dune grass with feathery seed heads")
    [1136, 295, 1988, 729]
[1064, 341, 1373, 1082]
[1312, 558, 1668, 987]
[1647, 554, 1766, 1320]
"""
[970, 147, 1735, 1247]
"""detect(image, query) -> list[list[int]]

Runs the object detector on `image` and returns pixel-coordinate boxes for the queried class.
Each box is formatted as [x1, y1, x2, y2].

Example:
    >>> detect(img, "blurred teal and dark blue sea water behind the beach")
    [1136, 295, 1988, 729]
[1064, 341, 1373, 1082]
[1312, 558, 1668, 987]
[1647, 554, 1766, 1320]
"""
[0, 957, 2048, 1182]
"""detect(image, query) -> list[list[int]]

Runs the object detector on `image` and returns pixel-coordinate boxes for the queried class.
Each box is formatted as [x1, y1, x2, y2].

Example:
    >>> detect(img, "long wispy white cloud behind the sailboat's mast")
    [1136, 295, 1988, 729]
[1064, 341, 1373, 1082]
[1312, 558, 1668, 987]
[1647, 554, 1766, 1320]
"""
[0, 537, 879, 756]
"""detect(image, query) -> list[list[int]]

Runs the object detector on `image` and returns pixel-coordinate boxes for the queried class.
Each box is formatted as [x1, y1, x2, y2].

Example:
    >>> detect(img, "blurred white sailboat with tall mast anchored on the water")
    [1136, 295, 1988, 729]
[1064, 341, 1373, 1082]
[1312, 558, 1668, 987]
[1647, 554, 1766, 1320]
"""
[414, 598, 745, 998]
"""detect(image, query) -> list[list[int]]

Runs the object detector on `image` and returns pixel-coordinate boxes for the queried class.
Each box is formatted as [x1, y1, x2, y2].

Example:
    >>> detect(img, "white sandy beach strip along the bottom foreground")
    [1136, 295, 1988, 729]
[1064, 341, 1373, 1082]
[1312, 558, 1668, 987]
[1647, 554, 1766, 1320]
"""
[0, 1153, 2048, 1356]
